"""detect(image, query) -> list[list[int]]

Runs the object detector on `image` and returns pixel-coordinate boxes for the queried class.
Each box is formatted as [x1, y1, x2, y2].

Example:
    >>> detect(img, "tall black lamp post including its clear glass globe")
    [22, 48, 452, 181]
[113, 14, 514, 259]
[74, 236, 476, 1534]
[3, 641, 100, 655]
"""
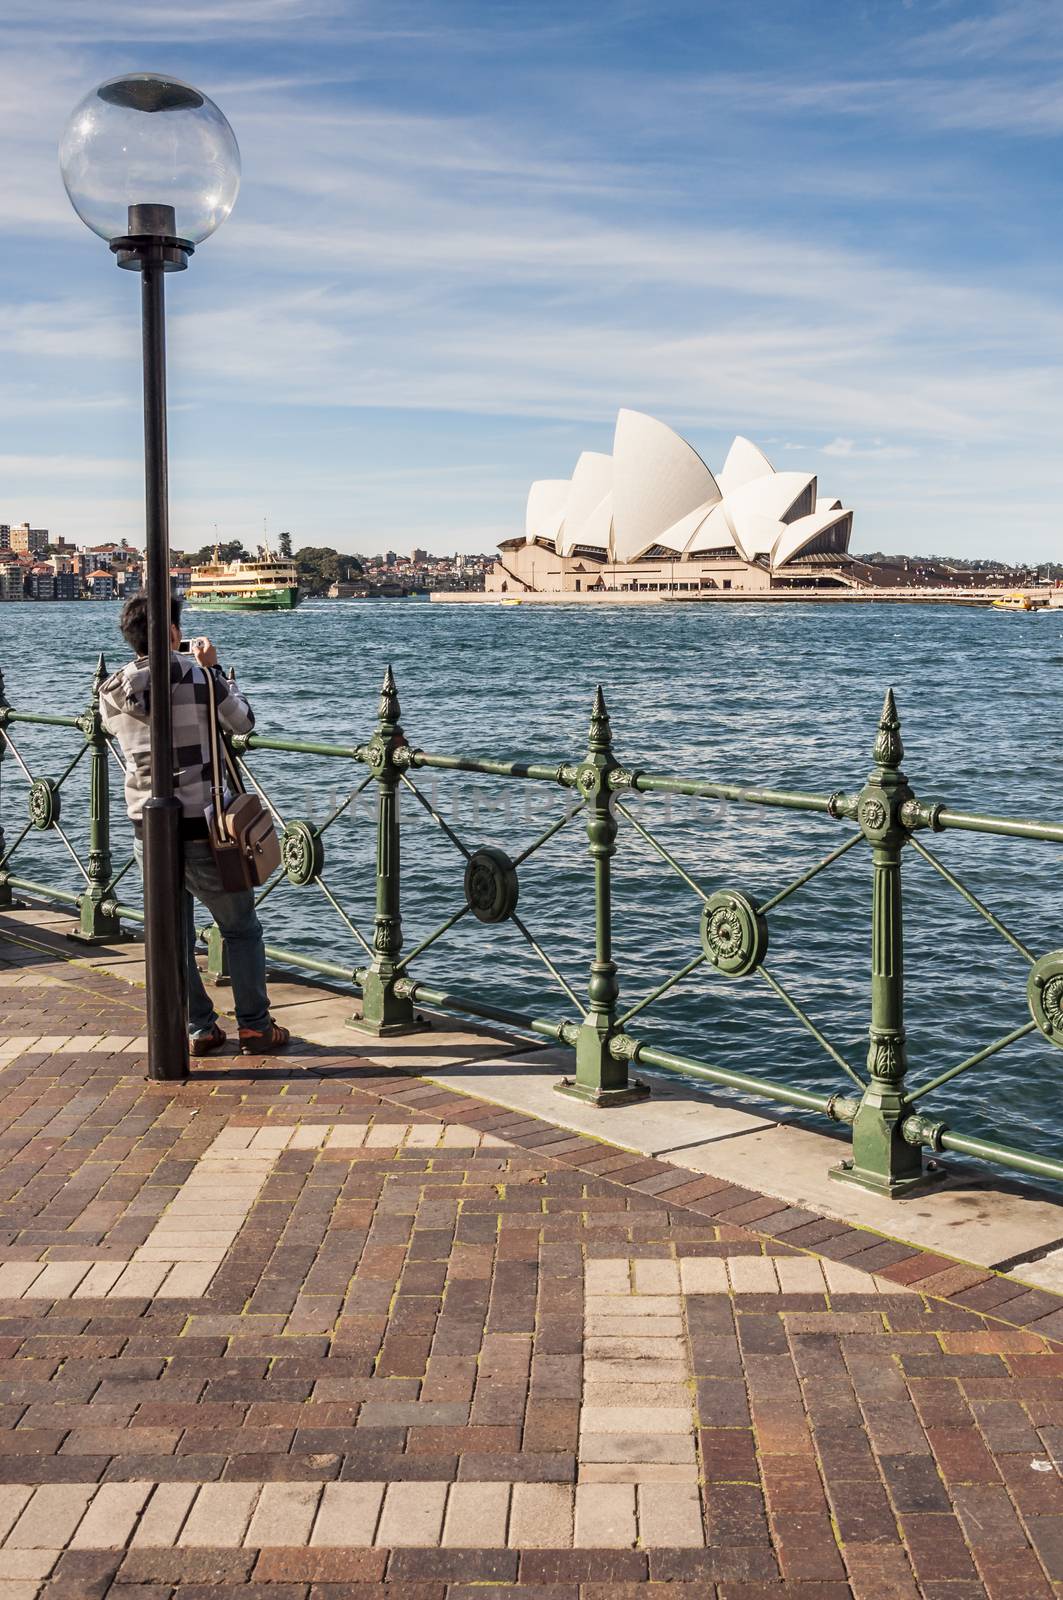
[59, 72, 240, 1080]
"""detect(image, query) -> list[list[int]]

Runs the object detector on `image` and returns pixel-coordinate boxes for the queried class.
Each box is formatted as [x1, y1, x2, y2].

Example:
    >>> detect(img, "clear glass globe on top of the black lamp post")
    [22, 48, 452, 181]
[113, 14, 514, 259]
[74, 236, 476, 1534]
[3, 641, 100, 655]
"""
[59, 72, 240, 246]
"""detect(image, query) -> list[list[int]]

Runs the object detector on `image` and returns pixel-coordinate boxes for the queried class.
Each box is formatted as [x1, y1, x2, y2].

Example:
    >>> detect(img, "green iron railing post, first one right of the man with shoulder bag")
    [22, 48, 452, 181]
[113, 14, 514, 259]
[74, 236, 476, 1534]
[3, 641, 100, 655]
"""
[349, 667, 418, 1037]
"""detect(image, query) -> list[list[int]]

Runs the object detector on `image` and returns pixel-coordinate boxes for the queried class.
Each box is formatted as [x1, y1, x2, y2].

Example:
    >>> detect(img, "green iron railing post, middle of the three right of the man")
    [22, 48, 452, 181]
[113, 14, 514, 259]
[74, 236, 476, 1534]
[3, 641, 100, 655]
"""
[557, 683, 650, 1106]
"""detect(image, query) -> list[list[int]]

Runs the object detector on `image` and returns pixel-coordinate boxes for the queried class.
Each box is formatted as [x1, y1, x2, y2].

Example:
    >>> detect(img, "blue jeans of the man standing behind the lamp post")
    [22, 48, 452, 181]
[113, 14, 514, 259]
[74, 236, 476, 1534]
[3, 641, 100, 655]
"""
[133, 838, 269, 1038]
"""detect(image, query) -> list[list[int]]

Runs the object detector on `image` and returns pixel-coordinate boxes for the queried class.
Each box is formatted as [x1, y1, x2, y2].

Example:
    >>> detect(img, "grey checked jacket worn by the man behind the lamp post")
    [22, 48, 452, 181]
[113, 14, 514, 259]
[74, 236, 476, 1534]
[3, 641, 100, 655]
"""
[99, 651, 255, 834]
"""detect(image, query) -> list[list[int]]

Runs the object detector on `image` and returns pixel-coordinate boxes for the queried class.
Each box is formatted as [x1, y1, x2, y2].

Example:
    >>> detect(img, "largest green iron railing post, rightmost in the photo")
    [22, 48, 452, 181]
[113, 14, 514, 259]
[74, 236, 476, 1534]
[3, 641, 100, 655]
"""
[831, 690, 925, 1195]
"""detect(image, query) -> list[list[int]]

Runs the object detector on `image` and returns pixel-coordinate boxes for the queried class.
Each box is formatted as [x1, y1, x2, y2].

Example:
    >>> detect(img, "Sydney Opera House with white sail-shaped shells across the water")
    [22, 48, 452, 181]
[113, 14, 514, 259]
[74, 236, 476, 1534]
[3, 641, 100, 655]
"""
[487, 411, 853, 595]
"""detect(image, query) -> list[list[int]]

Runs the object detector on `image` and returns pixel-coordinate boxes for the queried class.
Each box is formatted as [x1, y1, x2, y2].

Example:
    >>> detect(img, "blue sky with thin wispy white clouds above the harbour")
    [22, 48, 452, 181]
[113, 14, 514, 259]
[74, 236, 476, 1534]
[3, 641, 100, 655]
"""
[0, 0, 1063, 560]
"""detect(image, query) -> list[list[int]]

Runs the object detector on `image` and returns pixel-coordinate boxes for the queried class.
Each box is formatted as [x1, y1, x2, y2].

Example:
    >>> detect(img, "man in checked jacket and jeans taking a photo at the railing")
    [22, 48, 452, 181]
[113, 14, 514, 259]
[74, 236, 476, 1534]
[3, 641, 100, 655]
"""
[99, 595, 290, 1056]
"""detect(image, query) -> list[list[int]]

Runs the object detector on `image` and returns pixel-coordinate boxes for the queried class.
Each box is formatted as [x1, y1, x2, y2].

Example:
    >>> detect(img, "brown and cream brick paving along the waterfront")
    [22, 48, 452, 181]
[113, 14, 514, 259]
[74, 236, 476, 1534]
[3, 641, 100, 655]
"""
[0, 918, 1063, 1600]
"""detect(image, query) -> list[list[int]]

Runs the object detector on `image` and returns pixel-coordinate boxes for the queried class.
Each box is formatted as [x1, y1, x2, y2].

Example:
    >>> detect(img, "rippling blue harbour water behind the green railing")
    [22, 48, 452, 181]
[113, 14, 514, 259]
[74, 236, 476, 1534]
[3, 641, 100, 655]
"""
[0, 600, 1063, 1177]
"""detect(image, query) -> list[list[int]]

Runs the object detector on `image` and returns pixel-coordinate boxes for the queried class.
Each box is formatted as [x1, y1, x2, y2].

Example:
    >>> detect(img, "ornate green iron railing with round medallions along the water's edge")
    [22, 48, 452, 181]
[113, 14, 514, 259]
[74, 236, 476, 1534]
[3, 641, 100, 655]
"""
[0, 658, 1063, 1195]
